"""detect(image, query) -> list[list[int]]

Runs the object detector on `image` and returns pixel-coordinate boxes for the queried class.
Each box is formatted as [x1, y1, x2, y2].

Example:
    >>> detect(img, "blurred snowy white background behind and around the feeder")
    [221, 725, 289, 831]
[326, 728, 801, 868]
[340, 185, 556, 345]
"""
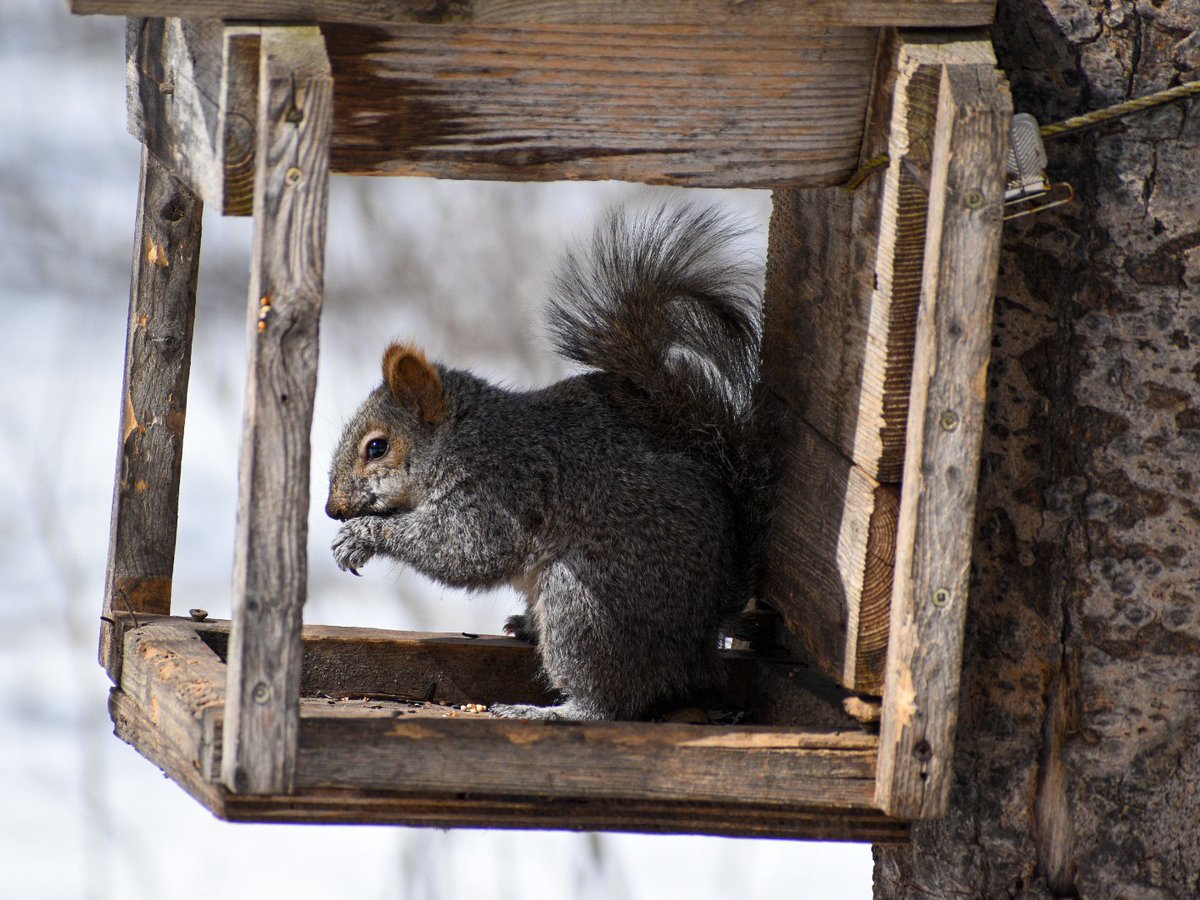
[0, 0, 871, 900]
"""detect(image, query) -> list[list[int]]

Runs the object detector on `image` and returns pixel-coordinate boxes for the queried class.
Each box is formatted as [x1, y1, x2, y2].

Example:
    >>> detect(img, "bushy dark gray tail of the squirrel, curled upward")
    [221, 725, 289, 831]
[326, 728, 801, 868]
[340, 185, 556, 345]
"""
[548, 205, 762, 455]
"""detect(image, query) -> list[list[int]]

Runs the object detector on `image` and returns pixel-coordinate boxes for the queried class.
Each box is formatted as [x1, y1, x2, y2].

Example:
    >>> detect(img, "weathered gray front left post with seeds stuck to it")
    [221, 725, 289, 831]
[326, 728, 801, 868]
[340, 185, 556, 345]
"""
[222, 26, 332, 793]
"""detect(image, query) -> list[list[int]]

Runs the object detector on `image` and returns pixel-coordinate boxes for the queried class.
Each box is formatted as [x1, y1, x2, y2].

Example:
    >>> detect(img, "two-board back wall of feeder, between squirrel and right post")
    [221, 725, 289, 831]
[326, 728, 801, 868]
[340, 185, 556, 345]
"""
[763, 31, 1000, 710]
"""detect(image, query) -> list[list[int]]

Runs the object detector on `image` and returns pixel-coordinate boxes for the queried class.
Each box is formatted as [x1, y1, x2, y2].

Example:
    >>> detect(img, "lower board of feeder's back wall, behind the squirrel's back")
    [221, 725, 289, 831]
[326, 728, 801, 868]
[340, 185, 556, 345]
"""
[763, 413, 899, 694]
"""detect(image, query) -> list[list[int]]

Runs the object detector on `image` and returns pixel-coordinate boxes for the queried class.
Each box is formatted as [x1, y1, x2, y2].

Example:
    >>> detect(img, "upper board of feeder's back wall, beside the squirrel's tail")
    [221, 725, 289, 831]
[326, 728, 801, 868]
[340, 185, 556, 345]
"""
[763, 32, 991, 484]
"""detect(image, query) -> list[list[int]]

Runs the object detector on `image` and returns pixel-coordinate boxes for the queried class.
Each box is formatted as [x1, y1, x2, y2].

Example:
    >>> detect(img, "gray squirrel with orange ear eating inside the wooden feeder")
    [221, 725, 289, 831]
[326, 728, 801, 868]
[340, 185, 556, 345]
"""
[325, 206, 772, 720]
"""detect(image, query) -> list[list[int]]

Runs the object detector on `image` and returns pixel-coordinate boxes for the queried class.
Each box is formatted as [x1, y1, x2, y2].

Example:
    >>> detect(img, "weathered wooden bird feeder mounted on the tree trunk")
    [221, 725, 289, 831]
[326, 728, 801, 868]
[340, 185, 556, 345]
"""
[72, 0, 1010, 842]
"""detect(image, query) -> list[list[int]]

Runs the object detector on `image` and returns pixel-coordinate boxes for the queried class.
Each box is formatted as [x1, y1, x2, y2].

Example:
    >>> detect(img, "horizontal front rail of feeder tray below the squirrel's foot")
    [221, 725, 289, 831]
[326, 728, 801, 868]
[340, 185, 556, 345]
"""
[296, 714, 876, 809]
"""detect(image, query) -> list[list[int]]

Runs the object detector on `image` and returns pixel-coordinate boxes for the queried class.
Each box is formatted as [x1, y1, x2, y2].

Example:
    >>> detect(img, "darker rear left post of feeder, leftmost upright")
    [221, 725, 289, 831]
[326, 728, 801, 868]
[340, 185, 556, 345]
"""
[100, 148, 204, 682]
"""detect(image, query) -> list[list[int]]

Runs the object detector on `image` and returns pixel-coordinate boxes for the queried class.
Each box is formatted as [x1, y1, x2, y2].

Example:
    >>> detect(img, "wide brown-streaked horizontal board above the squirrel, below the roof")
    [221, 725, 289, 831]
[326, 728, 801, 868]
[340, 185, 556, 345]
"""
[323, 24, 876, 187]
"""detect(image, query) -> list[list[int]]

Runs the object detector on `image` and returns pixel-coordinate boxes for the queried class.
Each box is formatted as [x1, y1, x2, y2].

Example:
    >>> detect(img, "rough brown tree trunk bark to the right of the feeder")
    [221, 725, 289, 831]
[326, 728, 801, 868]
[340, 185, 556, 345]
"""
[875, 0, 1200, 898]
